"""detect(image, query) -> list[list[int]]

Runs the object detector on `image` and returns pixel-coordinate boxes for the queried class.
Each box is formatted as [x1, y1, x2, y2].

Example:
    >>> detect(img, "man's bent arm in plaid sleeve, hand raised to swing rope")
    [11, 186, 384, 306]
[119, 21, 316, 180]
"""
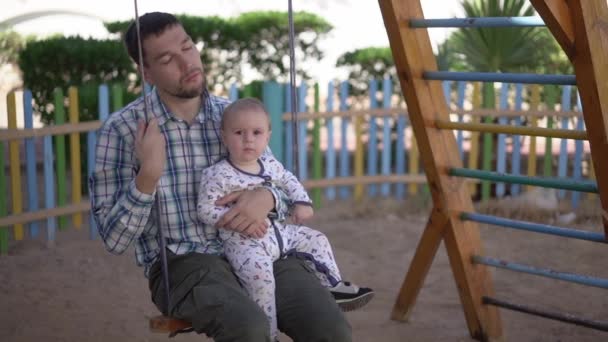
[90, 117, 164, 254]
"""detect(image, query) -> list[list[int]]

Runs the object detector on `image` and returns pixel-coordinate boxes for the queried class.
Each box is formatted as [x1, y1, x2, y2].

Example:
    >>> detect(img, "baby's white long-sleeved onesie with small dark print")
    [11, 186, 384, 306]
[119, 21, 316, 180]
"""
[197, 155, 341, 341]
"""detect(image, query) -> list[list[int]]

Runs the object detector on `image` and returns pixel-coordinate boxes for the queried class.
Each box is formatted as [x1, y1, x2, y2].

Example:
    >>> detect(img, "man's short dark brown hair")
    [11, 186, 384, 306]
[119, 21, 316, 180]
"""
[125, 12, 181, 65]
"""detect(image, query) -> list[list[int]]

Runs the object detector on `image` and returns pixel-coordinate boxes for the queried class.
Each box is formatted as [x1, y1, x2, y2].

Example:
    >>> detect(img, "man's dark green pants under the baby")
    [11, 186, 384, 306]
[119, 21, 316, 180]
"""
[149, 251, 352, 342]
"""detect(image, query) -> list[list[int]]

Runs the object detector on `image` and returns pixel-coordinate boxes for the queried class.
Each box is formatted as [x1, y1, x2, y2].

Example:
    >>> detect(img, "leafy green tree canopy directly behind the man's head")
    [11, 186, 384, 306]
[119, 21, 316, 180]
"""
[106, 11, 333, 85]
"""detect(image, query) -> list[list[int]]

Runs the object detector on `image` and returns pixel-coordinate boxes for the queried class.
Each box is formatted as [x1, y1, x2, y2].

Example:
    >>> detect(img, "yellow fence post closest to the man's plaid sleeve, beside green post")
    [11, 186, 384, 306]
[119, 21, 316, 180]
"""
[68, 86, 82, 228]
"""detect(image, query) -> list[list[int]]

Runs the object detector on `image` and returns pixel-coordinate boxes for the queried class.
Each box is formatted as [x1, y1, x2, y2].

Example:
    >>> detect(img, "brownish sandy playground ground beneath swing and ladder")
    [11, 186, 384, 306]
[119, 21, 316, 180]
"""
[0, 201, 608, 342]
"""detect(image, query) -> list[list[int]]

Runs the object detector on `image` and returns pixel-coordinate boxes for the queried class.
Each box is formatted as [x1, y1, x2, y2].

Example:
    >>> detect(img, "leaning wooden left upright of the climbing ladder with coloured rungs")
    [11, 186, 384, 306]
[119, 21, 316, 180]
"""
[379, 0, 502, 340]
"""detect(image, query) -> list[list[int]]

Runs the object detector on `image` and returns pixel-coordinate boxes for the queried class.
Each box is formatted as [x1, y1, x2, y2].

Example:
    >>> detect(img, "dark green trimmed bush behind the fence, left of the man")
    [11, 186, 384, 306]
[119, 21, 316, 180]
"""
[19, 37, 135, 123]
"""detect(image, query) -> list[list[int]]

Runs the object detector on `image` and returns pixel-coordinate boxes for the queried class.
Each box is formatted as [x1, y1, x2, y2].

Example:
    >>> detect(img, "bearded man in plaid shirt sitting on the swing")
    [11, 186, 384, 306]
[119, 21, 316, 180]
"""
[91, 12, 351, 342]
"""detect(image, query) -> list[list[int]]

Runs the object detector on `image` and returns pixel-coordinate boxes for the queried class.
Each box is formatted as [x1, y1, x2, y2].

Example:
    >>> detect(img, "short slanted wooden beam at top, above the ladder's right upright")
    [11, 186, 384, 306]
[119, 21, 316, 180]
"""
[530, 0, 574, 60]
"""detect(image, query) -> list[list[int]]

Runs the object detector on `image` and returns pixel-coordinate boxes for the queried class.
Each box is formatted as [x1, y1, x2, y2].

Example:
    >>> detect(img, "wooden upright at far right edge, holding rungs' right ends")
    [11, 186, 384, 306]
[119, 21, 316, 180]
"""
[568, 0, 608, 236]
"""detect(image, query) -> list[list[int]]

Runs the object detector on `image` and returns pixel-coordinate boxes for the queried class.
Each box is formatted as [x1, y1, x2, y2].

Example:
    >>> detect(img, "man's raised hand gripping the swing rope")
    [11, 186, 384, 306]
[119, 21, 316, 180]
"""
[135, 118, 167, 194]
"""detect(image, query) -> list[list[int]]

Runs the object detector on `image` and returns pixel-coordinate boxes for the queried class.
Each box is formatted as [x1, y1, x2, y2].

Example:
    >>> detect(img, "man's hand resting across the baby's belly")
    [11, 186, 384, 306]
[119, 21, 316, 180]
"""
[215, 188, 274, 238]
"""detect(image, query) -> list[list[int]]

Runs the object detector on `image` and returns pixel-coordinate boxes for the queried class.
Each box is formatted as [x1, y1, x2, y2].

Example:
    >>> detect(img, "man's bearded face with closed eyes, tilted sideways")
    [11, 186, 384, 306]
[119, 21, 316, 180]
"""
[142, 24, 206, 99]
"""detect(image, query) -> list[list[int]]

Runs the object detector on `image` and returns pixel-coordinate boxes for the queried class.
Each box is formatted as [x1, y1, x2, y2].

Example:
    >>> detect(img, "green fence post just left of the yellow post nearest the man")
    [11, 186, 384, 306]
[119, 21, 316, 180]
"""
[53, 89, 67, 229]
